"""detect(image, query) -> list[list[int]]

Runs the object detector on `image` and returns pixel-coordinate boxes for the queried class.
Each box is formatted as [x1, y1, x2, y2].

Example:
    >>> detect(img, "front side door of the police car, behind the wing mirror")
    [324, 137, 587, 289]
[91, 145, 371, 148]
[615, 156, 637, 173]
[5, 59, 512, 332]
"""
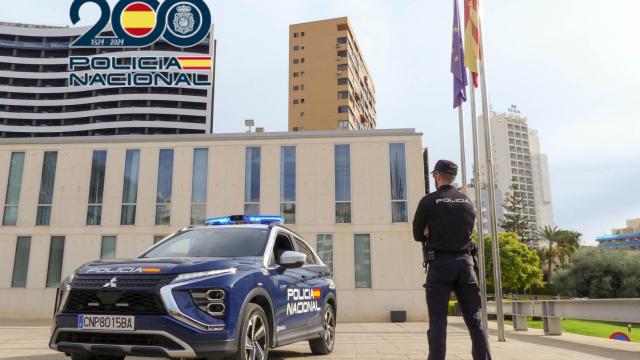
[269, 231, 304, 335]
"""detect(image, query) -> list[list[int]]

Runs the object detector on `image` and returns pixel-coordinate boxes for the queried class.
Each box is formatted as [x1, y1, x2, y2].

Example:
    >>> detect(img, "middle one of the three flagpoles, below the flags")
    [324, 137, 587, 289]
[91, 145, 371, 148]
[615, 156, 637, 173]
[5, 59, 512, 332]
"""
[469, 70, 488, 336]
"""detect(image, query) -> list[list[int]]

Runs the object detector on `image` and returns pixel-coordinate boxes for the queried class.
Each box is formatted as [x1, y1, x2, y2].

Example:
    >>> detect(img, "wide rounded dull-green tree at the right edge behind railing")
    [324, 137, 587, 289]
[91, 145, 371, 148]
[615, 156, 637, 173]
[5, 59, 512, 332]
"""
[556, 248, 640, 299]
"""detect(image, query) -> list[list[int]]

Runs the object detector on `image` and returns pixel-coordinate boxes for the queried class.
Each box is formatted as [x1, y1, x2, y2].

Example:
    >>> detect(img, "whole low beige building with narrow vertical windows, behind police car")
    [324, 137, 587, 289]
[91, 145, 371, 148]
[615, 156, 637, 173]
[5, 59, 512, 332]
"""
[0, 129, 426, 322]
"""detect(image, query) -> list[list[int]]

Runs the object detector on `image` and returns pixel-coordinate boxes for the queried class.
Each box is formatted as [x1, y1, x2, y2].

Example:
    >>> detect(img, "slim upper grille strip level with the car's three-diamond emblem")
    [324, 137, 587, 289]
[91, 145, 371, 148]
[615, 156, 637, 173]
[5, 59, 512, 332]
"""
[71, 274, 175, 290]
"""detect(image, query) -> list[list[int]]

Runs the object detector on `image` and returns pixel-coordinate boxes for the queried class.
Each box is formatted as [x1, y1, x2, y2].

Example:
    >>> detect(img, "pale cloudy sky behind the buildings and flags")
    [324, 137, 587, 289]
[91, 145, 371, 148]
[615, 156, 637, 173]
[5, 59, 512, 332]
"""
[0, 0, 640, 243]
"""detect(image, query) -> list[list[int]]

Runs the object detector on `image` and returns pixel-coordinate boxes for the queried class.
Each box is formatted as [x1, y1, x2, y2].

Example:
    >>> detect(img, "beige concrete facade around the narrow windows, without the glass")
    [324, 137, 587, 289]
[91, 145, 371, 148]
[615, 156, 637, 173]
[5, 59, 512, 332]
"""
[0, 130, 426, 321]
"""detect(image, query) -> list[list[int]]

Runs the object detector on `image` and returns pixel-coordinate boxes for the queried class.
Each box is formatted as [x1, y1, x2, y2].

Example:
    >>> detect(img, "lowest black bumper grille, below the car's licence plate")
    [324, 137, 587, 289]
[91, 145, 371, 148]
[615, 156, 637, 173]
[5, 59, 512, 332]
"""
[56, 331, 184, 350]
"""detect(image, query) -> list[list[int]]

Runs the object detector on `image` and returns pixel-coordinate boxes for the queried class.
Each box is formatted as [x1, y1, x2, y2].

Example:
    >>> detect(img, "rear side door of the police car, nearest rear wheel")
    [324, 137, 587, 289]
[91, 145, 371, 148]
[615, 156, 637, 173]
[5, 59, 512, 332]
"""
[294, 237, 331, 326]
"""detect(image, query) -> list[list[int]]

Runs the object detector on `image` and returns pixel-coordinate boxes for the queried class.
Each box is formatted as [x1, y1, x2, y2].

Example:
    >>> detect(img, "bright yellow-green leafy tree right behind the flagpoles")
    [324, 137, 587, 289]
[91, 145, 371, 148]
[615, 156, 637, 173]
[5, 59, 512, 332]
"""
[476, 232, 542, 289]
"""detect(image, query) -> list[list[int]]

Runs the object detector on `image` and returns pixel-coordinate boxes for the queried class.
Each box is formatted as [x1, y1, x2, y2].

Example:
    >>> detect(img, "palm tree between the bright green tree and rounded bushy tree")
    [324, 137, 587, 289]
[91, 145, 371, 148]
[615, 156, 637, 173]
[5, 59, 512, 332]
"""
[537, 225, 581, 284]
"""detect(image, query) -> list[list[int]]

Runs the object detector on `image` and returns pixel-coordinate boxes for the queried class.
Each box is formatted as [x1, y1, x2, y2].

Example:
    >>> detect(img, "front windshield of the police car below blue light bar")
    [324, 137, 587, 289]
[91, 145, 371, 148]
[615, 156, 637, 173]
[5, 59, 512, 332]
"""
[142, 227, 269, 258]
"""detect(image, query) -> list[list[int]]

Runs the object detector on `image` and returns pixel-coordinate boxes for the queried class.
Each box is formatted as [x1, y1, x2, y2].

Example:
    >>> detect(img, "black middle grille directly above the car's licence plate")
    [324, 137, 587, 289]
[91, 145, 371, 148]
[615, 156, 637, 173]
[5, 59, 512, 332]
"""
[63, 289, 165, 315]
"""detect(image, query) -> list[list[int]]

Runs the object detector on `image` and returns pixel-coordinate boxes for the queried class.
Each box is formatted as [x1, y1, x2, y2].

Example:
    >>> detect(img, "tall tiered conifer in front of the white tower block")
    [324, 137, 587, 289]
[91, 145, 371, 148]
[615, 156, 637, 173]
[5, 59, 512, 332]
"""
[500, 184, 534, 247]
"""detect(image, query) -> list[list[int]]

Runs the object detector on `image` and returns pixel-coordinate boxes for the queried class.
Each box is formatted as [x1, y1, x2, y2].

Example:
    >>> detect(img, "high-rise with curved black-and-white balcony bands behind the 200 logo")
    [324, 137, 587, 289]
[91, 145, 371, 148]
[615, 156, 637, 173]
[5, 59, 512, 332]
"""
[0, 23, 214, 138]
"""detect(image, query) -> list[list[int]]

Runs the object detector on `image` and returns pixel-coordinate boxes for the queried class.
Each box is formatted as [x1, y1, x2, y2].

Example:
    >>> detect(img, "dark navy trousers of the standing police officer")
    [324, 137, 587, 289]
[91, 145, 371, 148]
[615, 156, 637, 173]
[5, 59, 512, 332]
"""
[425, 253, 491, 360]
